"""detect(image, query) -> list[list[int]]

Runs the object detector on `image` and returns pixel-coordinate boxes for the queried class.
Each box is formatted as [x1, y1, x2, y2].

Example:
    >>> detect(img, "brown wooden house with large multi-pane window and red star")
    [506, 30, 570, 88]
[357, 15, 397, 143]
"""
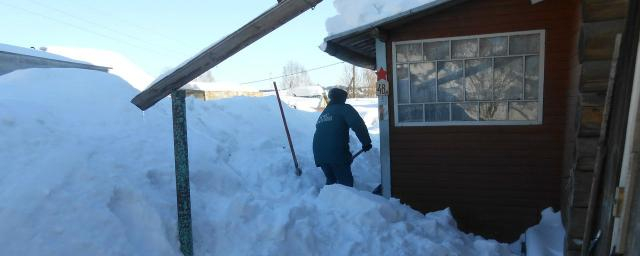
[324, 0, 640, 255]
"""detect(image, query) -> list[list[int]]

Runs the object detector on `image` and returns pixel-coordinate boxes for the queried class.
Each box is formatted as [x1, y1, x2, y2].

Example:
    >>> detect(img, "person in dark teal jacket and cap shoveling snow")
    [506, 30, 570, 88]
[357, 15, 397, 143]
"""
[313, 88, 372, 187]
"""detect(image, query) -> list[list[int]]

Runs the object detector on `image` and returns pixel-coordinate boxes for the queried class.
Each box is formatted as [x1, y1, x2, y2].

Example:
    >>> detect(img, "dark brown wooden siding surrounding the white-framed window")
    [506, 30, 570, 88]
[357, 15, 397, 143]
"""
[387, 0, 577, 242]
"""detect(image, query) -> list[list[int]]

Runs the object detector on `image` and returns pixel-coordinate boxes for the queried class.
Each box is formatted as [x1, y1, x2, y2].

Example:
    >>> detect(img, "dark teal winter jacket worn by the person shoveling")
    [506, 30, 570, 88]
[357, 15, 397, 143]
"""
[313, 91, 371, 166]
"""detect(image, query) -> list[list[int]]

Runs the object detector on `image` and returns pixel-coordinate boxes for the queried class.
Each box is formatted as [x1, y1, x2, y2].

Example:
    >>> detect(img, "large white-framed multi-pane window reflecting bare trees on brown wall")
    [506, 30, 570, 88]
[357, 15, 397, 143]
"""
[393, 30, 545, 126]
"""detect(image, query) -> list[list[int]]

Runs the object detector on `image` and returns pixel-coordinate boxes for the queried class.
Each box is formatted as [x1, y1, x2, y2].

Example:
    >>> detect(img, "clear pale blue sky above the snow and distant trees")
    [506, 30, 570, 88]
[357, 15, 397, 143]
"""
[0, 0, 350, 86]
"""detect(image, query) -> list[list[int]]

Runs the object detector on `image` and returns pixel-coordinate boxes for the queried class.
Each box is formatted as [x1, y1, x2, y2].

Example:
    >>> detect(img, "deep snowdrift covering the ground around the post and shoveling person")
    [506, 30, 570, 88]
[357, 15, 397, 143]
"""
[0, 69, 510, 255]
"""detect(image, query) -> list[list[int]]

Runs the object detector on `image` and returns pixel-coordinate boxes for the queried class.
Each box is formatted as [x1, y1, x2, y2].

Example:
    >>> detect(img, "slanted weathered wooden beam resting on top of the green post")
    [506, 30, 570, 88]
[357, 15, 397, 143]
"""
[131, 0, 322, 110]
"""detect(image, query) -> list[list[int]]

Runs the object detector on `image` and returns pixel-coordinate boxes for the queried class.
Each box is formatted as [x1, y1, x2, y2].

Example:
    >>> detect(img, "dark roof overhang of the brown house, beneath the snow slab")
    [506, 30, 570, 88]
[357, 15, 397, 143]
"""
[324, 0, 468, 69]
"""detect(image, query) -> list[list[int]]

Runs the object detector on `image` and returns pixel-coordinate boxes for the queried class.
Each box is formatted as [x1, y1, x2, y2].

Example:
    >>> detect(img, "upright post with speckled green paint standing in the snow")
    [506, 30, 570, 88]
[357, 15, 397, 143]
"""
[171, 90, 193, 256]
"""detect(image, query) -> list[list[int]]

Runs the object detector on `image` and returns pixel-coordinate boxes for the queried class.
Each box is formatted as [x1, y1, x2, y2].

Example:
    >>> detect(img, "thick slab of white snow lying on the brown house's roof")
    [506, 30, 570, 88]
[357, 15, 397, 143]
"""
[325, 0, 434, 35]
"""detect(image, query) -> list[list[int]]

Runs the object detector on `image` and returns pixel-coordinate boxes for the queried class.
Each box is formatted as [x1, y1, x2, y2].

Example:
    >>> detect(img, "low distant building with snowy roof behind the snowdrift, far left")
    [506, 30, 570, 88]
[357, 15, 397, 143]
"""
[0, 44, 109, 75]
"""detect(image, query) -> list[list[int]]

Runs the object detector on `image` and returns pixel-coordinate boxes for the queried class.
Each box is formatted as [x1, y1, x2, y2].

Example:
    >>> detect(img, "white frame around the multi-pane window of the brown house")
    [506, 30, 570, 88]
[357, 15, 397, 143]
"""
[391, 29, 546, 127]
